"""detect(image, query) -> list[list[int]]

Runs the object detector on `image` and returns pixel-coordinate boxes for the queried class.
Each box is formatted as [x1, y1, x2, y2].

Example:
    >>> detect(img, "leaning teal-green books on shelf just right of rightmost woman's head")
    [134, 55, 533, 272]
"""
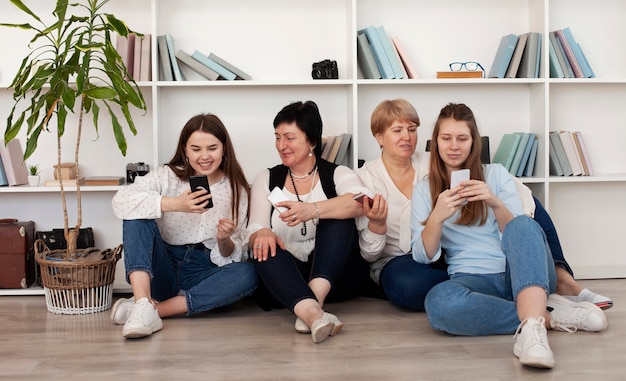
[493, 132, 539, 177]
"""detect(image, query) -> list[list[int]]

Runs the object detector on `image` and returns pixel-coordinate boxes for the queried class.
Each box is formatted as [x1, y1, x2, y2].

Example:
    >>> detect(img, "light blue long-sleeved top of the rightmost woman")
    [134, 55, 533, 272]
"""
[411, 164, 523, 274]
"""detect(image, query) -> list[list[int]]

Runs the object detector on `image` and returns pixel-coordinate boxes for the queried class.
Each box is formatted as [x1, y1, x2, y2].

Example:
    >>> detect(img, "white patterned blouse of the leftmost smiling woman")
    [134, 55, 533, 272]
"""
[112, 165, 248, 266]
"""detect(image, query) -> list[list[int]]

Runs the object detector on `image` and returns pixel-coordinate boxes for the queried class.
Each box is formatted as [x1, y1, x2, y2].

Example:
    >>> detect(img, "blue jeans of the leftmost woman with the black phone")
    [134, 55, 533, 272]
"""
[123, 220, 257, 316]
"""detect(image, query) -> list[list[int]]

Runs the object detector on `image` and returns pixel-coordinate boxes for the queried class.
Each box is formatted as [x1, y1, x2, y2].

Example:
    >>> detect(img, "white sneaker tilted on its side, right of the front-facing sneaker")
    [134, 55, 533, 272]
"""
[548, 294, 609, 332]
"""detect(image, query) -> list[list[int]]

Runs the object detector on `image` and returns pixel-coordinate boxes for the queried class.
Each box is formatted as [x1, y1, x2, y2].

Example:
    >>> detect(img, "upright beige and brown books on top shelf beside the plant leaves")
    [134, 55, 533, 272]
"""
[115, 33, 152, 81]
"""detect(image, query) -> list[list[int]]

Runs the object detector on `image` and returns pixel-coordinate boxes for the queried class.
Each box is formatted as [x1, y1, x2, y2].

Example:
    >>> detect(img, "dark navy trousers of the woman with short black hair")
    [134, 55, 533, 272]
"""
[254, 219, 369, 312]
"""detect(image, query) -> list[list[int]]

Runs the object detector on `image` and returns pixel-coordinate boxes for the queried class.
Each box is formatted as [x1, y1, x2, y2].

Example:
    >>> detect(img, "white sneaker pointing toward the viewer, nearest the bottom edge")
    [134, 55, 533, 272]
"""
[513, 316, 554, 368]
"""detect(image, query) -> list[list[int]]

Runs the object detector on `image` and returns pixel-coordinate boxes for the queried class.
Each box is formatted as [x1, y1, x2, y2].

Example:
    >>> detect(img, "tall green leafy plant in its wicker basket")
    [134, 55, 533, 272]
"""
[0, 0, 147, 314]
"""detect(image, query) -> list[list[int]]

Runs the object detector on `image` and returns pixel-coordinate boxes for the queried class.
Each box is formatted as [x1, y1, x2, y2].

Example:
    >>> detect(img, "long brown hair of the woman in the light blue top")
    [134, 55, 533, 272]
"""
[428, 103, 487, 225]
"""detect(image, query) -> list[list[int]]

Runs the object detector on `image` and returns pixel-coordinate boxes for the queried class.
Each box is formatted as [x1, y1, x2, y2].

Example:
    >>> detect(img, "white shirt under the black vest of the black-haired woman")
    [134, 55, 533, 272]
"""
[248, 165, 363, 262]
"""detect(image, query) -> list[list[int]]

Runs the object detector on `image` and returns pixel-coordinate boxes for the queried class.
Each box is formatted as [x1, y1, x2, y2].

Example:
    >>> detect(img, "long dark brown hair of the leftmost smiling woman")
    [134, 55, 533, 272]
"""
[167, 114, 250, 224]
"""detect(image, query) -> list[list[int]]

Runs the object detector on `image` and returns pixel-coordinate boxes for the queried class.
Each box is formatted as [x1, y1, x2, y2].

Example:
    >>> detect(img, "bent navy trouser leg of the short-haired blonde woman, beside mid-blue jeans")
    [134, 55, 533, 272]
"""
[380, 254, 448, 311]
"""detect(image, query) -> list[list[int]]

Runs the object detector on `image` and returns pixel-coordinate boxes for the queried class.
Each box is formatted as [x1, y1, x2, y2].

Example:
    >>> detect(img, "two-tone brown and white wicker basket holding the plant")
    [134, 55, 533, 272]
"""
[35, 240, 122, 315]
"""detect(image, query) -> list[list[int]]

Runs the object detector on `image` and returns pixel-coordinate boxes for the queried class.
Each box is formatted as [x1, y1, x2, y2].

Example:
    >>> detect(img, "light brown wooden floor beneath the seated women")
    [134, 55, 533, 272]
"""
[0, 279, 626, 381]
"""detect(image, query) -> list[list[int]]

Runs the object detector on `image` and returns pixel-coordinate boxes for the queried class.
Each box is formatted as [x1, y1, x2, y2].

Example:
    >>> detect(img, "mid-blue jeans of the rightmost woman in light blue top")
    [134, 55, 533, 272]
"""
[425, 216, 556, 336]
